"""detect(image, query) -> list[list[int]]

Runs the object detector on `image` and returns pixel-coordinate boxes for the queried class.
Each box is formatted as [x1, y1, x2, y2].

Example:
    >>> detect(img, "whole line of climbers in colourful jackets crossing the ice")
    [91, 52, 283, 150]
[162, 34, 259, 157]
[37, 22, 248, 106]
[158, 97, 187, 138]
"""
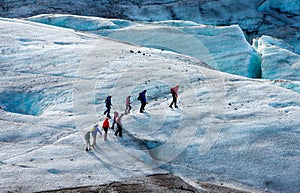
[84, 84, 179, 151]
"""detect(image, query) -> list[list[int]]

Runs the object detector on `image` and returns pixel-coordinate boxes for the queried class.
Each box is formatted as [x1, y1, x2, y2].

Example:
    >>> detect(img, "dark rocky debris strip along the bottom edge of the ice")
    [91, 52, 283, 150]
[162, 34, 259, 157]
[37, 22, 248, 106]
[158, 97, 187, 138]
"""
[40, 174, 254, 193]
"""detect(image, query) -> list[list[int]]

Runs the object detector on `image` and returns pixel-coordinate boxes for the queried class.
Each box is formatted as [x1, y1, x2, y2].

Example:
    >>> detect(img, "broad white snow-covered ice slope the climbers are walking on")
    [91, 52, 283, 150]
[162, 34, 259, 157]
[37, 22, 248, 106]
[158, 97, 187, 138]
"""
[0, 18, 300, 192]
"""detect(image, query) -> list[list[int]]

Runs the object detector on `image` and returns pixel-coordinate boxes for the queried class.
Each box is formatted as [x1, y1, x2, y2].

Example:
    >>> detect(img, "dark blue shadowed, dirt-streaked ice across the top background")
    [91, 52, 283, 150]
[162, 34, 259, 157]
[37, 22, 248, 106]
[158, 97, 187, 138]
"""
[0, 0, 300, 54]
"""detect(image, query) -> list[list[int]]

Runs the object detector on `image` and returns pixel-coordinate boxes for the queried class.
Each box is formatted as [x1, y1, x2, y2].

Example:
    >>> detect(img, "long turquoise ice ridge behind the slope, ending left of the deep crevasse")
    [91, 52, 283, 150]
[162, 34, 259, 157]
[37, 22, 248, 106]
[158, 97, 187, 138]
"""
[28, 15, 261, 78]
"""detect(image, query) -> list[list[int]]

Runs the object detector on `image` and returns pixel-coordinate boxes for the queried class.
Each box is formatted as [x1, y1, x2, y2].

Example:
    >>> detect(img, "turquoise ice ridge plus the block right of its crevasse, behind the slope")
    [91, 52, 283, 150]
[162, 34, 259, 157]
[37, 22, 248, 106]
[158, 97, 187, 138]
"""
[28, 14, 300, 80]
